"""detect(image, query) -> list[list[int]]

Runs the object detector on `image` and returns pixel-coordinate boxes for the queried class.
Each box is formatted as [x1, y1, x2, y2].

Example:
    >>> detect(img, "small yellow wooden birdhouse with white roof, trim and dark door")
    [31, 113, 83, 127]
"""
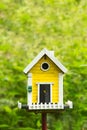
[19, 49, 72, 110]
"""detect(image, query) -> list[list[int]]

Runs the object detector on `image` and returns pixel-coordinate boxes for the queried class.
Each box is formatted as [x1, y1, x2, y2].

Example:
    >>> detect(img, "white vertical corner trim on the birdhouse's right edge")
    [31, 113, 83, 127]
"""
[58, 73, 63, 107]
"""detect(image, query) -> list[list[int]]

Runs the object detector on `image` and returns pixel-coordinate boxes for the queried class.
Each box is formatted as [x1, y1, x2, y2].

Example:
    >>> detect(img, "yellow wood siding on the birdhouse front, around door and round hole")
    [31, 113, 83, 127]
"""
[29, 56, 60, 103]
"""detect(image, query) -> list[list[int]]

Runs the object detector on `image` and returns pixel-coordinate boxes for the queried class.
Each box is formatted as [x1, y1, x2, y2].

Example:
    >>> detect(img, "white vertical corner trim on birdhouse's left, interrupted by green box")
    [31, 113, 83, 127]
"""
[27, 73, 32, 105]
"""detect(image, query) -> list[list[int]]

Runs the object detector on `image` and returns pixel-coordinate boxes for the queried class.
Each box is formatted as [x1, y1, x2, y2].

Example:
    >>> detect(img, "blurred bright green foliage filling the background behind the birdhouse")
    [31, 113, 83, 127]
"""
[0, 0, 87, 130]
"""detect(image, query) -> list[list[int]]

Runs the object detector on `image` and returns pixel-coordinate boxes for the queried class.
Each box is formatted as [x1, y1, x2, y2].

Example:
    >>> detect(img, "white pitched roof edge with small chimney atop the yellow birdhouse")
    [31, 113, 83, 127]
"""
[24, 49, 67, 74]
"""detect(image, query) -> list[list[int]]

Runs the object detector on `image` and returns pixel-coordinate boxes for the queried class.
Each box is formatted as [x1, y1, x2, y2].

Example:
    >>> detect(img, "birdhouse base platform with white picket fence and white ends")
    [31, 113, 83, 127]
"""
[18, 101, 73, 112]
